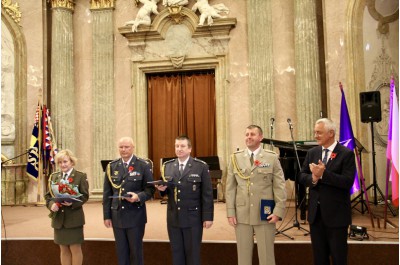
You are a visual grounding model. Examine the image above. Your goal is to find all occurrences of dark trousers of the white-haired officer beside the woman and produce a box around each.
[113,224,145,265]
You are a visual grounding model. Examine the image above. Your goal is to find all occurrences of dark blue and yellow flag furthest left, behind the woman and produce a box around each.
[26,104,42,181]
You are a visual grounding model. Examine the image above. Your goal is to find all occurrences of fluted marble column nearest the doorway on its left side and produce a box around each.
[91,0,116,199]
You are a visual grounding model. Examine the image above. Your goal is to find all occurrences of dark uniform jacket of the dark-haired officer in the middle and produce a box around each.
[162,157,214,228]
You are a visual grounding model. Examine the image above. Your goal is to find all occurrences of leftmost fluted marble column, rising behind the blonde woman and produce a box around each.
[50,0,75,152]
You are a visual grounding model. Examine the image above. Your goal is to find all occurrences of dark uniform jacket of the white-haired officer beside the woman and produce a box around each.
[103,156,155,228]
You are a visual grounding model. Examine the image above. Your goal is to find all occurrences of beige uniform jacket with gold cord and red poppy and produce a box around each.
[226,149,286,225]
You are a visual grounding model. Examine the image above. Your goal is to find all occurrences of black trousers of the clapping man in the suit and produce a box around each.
[310,206,347,265]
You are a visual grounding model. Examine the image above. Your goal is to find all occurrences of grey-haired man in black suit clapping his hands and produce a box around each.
[300,118,356,265]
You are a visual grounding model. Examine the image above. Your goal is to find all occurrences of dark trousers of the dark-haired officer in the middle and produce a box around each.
[168,225,203,265]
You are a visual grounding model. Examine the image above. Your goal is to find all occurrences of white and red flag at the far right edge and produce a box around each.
[386,77,399,207]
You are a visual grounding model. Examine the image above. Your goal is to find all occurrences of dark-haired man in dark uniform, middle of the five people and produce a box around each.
[156,136,214,265]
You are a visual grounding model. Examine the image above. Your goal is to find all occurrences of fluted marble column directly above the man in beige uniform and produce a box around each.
[247,0,275,128]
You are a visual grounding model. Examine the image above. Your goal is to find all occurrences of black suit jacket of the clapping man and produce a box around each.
[300,143,356,227]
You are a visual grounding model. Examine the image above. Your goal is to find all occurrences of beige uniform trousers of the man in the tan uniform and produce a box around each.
[235,223,275,265]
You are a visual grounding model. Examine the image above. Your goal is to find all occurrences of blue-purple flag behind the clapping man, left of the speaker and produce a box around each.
[339,83,360,194]
